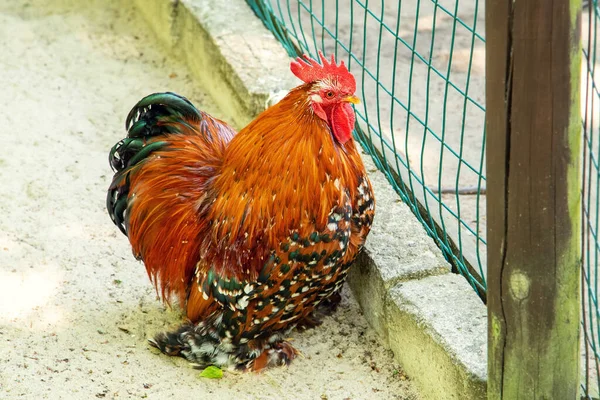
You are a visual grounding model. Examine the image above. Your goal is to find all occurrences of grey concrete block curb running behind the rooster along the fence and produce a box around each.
[135,0,487,399]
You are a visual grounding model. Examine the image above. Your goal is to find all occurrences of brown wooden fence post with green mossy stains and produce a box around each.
[486,0,581,400]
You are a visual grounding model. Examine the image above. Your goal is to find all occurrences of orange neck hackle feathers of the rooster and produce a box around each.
[206,84,363,278]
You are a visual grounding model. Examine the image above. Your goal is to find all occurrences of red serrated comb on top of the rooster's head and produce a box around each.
[290,51,356,93]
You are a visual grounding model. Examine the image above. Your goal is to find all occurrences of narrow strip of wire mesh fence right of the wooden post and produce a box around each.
[581,0,600,398]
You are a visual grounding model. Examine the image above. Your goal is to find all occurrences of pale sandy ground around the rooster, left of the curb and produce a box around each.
[0,0,417,399]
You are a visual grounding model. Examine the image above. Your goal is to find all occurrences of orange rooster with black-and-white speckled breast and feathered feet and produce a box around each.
[107,53,375,371]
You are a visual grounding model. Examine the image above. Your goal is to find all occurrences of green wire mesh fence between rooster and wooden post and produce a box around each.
[247,0,486,297]
